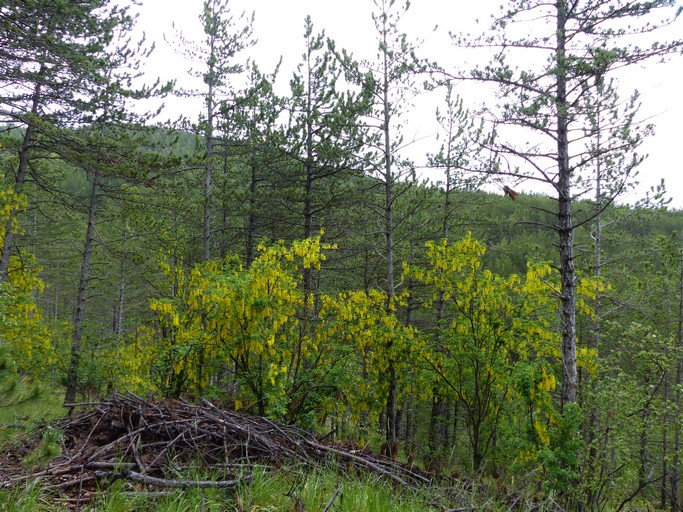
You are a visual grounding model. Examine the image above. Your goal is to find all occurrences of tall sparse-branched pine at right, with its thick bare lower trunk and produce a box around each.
[455,0,682,410]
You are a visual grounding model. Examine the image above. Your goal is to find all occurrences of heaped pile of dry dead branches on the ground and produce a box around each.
[0,393,428,495]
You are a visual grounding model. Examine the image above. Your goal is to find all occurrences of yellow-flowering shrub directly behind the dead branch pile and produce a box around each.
[143,236,352,422]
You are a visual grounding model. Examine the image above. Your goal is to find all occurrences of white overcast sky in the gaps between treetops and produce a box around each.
[138,0,683,208]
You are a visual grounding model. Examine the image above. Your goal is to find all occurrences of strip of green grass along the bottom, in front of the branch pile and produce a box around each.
[0,467,561,512]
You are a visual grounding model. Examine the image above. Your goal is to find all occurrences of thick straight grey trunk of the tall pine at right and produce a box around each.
[556,0,577,406]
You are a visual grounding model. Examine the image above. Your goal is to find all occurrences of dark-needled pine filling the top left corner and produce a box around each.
[0,0,132,280]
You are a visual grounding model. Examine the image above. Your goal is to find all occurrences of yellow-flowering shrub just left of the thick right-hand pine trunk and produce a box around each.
[404,235,560,469]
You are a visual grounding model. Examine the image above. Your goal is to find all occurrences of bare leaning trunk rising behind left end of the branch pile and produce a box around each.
[64,168,102,403]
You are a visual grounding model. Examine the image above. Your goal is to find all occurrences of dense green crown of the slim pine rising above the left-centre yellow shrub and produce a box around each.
[284,16,369,295]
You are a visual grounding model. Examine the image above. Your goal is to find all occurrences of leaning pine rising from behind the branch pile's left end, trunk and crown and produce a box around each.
[60,11,172,403]
